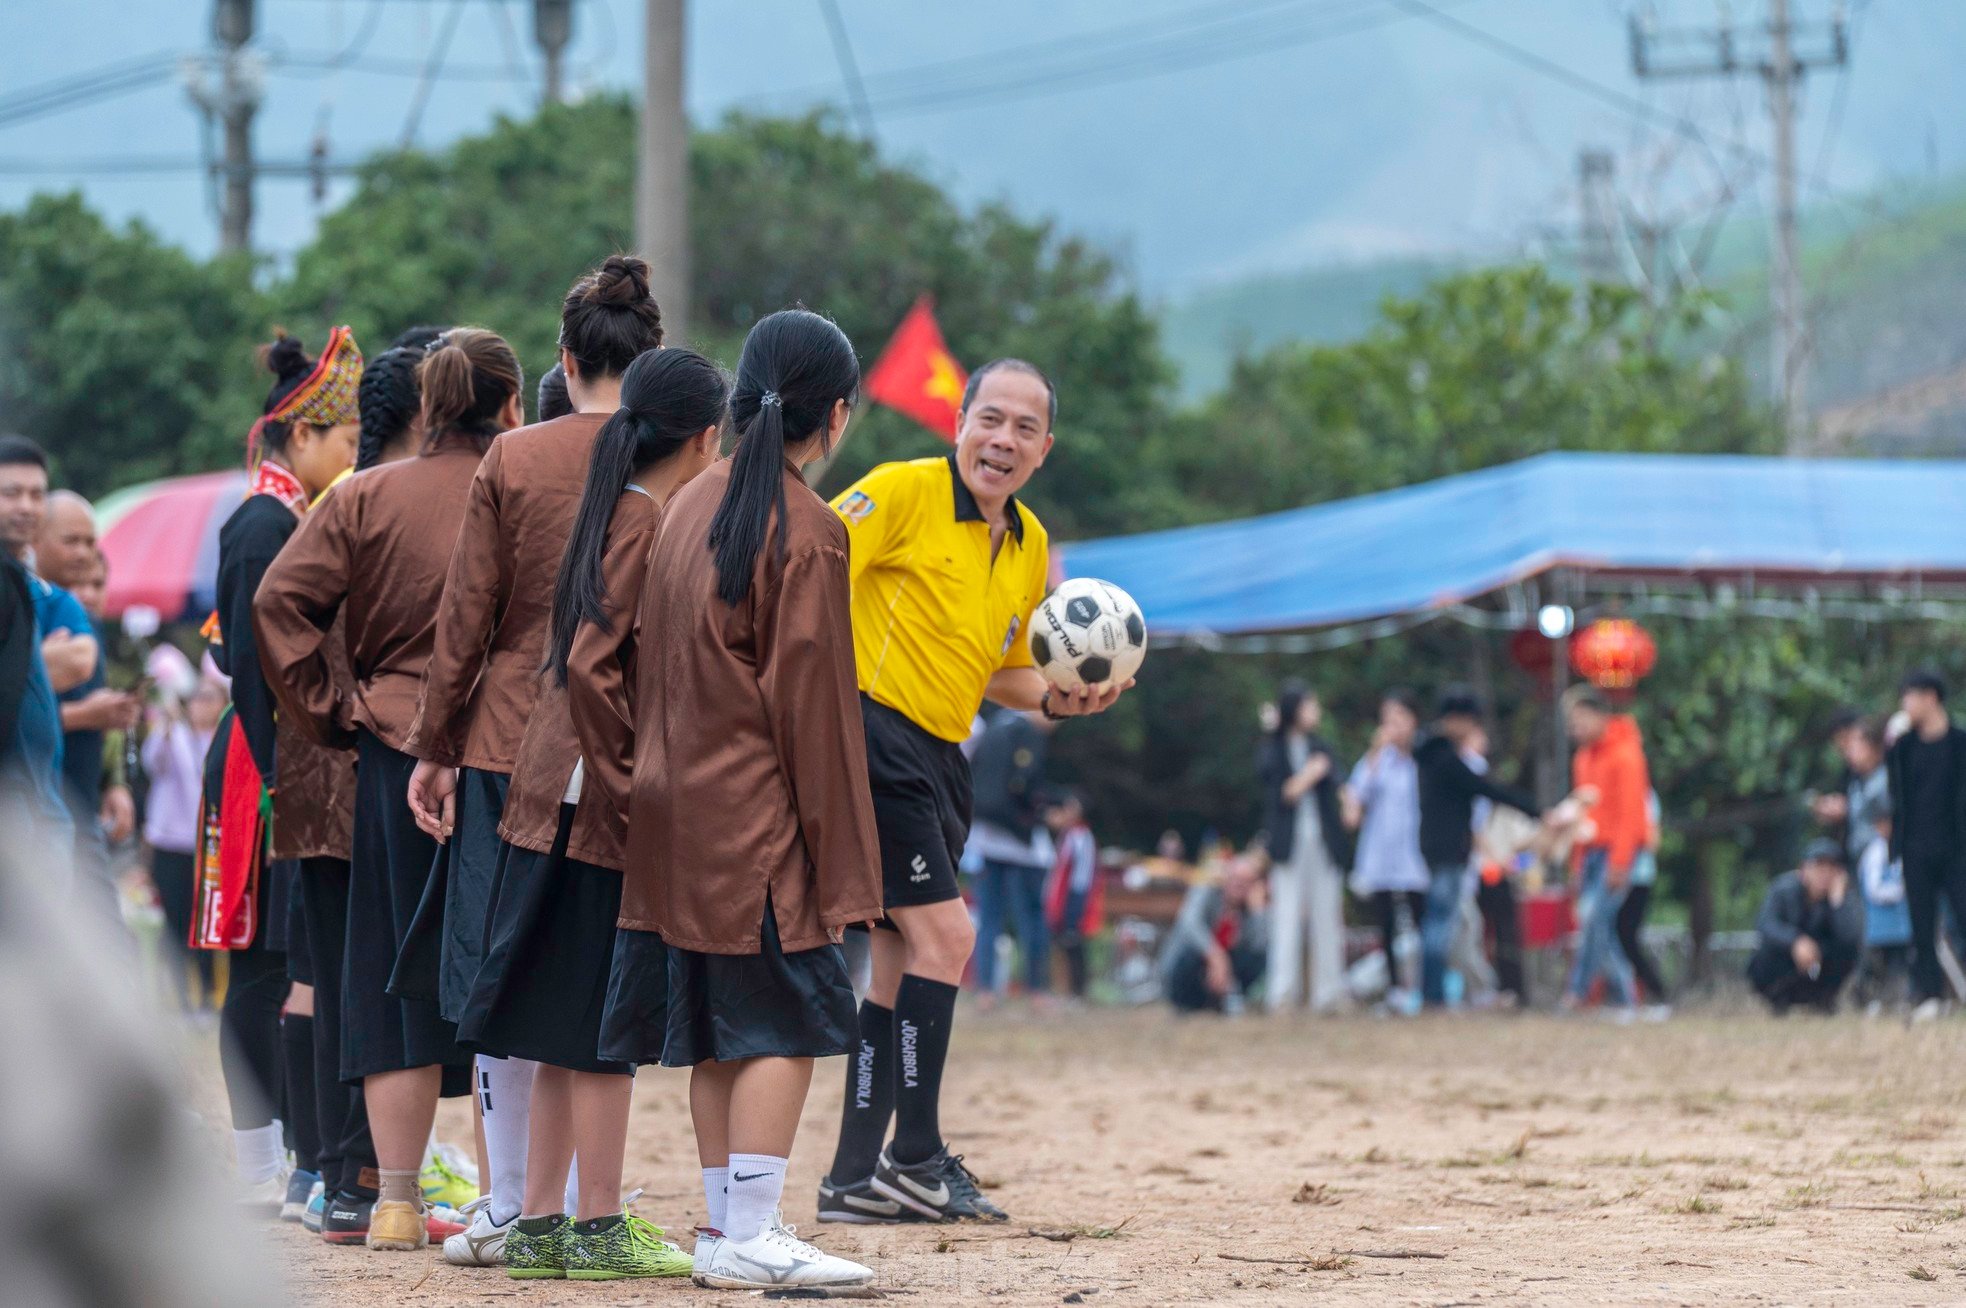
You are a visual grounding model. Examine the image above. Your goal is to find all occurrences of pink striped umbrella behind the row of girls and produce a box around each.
[96,468,248,622]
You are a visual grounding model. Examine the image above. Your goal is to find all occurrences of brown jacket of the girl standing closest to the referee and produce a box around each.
[619,462,881,954]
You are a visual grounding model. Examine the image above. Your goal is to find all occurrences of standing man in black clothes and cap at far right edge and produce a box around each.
[1885,669,1966,1021]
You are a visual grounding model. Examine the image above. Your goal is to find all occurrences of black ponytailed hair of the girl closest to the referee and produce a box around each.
[710,309,859,604]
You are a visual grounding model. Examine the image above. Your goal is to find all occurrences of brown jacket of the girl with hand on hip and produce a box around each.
[254,443,478,749]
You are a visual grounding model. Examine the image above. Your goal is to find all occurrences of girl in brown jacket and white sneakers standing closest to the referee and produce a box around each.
[602,309,881,1288]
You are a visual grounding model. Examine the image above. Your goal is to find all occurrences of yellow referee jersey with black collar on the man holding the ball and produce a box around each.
[834,454,1050,742]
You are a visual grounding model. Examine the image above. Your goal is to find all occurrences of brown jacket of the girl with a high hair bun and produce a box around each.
[403,413,607,773]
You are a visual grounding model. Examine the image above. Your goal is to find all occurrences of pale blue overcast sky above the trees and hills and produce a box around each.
[15,0,1966,293]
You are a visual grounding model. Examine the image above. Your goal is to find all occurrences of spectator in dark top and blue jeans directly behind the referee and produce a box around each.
[969,710,1056,1007]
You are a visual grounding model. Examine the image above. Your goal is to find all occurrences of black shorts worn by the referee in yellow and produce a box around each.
[861,694,969,930]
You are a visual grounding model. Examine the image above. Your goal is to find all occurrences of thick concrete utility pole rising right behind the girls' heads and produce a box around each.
[635,0,690,340]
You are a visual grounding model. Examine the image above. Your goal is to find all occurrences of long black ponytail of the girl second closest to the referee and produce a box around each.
[547,350,729,686]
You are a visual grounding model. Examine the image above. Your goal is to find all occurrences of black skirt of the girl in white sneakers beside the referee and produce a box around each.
[602,899,859,1068]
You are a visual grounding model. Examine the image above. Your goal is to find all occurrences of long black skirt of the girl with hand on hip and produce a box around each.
[342,730,472,1094]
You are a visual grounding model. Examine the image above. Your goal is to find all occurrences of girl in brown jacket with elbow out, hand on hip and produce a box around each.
[258,327,521,1249]
